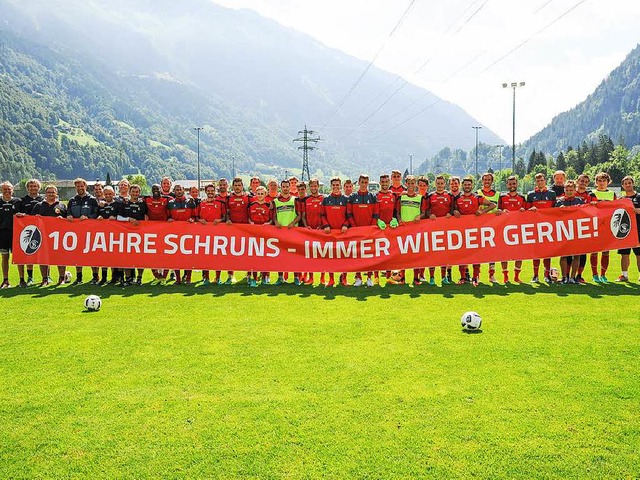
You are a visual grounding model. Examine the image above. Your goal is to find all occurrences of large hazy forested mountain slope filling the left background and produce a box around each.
[0,0,501,180]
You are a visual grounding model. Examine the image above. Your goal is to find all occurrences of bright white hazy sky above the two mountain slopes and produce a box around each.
[214,0,640,144]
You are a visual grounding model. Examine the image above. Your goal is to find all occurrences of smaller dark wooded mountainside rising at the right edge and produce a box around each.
[524,45,640,155]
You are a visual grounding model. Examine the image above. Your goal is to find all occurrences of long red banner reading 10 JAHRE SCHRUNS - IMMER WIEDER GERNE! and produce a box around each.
[13,200,639,272]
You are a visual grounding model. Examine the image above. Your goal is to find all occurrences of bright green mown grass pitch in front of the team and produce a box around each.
[0,255,640,479]
